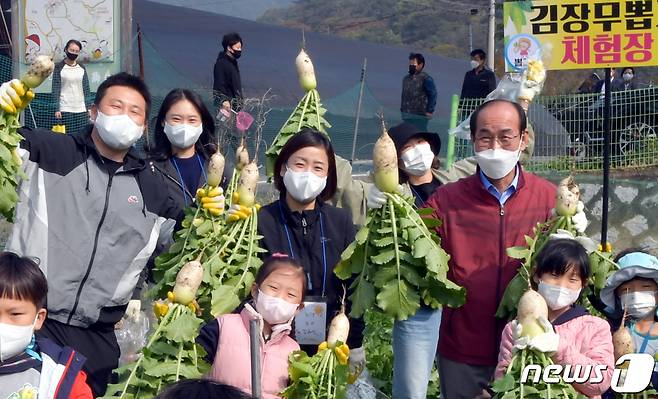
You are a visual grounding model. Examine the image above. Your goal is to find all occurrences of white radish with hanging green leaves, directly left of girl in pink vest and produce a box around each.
[105,261,210,399]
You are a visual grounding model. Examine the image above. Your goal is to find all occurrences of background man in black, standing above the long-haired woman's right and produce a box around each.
[213,33,242,110]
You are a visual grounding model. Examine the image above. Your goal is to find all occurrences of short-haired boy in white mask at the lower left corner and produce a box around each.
[0,252,93,399]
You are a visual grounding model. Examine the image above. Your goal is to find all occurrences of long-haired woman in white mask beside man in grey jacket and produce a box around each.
[149,89,216,208]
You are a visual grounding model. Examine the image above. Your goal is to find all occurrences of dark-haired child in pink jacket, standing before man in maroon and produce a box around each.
[495,239,614,398]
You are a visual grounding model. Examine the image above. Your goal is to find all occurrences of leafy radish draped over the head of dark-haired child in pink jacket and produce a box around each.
[496,176,619,319]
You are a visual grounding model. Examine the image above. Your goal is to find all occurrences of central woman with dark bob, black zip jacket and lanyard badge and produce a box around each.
[258,129,363,353]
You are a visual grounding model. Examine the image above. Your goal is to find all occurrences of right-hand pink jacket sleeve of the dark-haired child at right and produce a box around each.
[553,316,615,396]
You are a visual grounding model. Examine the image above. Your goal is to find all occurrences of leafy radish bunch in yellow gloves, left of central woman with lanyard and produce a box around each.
[152,149,265,320]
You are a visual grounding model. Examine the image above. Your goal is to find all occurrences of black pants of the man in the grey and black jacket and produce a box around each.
[37,319,121,398]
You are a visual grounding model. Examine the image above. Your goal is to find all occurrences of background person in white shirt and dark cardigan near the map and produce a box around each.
[52,39,91,133]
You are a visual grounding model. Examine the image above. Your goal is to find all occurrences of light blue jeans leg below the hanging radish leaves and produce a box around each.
[393,308,441,399]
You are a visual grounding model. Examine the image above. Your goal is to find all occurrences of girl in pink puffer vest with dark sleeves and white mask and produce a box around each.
[197,253,306,399]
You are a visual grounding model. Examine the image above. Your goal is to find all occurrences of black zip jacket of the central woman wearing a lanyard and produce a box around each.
[258,197,364,348]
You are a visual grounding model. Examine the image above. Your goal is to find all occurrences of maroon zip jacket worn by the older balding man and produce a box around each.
[427,169,556,366]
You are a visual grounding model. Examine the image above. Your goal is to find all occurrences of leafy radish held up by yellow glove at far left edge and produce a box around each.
[0,55,54,222]
